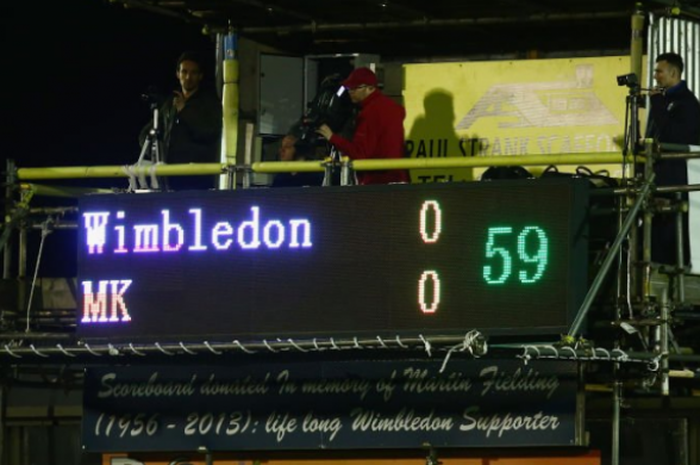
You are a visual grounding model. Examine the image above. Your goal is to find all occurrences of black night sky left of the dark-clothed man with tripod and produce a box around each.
[0,0,215,170]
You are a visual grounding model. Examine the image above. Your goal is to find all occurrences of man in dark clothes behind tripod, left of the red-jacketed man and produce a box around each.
[139,52,222,190]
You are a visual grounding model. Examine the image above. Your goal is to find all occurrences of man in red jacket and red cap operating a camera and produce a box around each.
[317,68,409,184]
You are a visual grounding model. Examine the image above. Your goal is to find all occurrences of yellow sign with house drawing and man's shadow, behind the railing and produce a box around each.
[403,57,630,182]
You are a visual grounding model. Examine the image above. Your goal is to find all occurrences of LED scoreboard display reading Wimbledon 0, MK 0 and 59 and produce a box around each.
[77,179,588,340]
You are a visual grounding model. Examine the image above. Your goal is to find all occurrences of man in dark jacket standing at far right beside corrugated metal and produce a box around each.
[647,53,700,264]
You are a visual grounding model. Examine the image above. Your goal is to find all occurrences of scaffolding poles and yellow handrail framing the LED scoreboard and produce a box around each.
[0,140,700,463]
